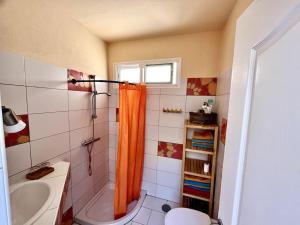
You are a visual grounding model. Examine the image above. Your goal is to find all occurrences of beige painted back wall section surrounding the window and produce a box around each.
[108,31,221,78]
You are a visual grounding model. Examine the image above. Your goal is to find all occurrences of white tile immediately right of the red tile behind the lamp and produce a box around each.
[29,112,69,141]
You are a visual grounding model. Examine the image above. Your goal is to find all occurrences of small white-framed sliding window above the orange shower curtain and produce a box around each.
[115,59,181,87]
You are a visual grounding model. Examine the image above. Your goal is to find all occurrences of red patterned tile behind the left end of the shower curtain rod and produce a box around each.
[68,69,92,92]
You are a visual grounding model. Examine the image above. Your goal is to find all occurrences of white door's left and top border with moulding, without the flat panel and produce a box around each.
[219,0,300,225]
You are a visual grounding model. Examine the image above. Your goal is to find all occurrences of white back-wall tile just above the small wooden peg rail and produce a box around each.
[160,95,186,111]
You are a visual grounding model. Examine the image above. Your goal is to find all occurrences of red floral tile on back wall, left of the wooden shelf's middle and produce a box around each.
[157,141,183,160]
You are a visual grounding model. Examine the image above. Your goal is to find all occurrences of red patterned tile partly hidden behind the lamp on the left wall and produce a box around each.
[5,115,30,147]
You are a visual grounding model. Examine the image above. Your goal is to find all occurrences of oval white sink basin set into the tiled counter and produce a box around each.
[10,181,55,225]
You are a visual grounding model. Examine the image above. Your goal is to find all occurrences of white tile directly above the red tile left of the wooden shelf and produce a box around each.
[159,127,183,144]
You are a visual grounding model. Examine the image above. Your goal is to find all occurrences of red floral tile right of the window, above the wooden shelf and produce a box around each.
[186,78,218,96]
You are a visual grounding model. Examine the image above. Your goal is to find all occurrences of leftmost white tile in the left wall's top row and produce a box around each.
[0,52,25,85]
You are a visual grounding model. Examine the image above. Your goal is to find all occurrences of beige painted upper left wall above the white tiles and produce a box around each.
[0,0,107,77]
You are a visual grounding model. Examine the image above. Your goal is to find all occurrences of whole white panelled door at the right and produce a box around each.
[219,0,300,225]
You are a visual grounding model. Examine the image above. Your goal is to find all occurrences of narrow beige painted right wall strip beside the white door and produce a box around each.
[218,0,253,74]
